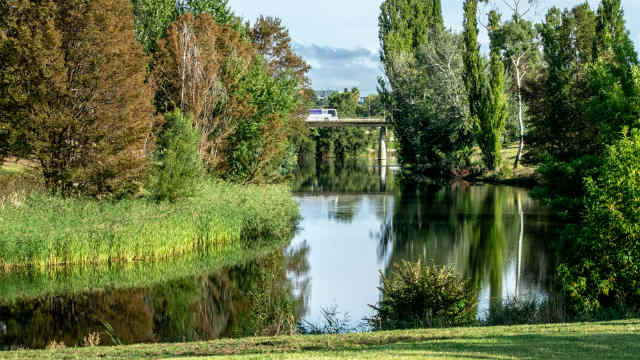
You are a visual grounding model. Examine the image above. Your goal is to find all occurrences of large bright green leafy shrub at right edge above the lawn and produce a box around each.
[559,131,640,314]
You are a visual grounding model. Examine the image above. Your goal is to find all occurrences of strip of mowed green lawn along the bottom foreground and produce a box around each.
[0,320,640,360]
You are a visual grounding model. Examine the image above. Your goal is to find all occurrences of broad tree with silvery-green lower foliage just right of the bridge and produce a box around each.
[379,1,473,175]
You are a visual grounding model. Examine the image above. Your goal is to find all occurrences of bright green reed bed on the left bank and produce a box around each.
[0,183,298,270]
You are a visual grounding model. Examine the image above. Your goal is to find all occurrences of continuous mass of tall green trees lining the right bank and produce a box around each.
[379,0,640,315]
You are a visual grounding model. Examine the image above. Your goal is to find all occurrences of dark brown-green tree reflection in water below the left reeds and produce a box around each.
[0,246,308,349]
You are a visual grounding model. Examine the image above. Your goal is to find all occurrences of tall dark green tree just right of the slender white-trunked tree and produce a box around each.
[523,4,597,161]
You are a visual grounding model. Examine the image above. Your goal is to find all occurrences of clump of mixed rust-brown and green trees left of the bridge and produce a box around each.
[154,13,308,182]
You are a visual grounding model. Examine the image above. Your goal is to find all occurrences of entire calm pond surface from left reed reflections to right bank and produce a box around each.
[0,163,554,349]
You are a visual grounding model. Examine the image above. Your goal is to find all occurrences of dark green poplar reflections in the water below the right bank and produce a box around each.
[374,183,552,311]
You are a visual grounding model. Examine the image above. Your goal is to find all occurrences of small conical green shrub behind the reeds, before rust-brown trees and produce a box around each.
[151,110,202,201]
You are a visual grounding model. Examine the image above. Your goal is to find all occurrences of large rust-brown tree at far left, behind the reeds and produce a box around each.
[0,0,153,196]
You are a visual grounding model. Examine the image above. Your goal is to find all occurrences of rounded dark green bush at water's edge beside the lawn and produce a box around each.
[369,261,476,330]
